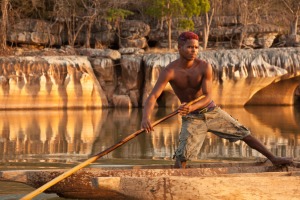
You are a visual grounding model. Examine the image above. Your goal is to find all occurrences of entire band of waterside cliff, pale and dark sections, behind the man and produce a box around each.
[0,48,300,109]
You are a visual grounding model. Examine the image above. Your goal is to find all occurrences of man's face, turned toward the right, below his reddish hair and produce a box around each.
[179,39,199,60]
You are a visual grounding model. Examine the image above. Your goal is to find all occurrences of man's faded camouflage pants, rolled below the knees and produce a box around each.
[174,107,250,161]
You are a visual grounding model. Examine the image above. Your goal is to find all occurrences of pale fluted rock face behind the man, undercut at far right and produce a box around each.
[143,48,300,106]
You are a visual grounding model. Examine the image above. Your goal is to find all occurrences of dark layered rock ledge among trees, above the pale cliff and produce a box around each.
[7,16,300,49]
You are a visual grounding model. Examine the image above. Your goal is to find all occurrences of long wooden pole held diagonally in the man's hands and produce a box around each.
[20,96,204,200]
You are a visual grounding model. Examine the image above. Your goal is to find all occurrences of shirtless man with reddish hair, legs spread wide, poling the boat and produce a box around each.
[141,32,293,168]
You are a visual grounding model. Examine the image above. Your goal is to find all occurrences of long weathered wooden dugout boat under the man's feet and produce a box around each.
[0,162,300,200]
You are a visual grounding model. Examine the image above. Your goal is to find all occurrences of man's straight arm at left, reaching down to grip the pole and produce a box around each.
[141,69,171,132]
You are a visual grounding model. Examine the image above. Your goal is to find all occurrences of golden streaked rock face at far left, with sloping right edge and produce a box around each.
[0,56,107,109]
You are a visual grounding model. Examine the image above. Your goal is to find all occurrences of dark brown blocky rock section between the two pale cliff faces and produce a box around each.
[90,55,144,107]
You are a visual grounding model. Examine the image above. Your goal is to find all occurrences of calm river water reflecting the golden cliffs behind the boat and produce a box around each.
[0,106,300,200]
